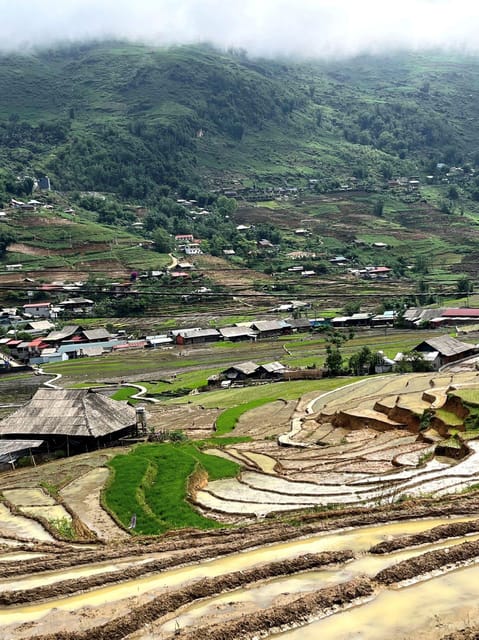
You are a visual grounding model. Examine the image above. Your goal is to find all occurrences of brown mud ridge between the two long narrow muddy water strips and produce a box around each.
[28,551,357,640]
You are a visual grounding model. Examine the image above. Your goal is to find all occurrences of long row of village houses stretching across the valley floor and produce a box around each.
[0,298,479,371]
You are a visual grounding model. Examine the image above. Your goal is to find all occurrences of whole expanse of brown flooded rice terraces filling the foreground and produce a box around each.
[0,372,479,640]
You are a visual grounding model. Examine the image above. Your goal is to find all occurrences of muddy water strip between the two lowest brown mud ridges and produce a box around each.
[147,534,479,640]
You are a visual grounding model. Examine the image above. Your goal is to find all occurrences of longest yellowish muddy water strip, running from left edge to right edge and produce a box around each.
[0,516,474,625]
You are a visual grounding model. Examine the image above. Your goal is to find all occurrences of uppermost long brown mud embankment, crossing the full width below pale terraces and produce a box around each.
[2,492,479,589]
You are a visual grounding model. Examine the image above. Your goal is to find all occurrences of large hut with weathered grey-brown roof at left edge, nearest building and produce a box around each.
[0,388,135,448]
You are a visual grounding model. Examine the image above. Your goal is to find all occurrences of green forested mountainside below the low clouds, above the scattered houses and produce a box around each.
[0,43,479,202]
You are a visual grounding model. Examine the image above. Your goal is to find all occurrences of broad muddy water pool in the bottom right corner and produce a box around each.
[273,565,479,640]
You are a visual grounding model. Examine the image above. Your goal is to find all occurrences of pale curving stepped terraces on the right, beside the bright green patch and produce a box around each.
[195,372,479,517]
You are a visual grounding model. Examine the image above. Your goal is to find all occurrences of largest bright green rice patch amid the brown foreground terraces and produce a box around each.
[104,443,239,535]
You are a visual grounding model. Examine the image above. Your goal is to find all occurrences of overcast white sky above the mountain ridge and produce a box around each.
[0,0,479,57]
